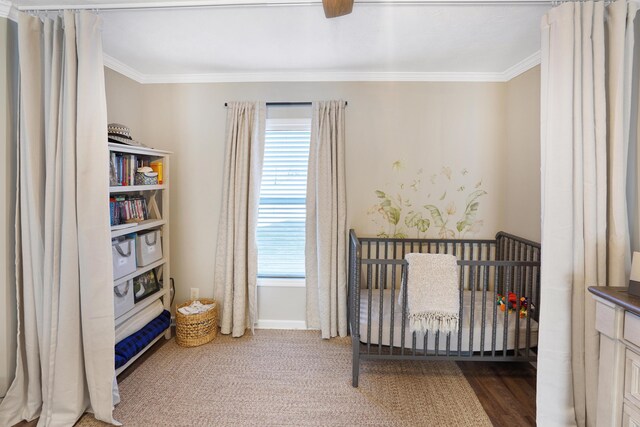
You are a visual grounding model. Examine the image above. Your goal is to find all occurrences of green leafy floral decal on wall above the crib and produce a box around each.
[368,160,487,238]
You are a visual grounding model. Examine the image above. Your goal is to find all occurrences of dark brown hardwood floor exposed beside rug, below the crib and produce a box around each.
[458,362,536,427]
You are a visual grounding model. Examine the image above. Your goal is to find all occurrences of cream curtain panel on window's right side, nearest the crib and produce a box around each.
[305,101,347,338]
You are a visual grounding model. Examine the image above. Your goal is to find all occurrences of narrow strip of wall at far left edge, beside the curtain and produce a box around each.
[0,18,18,398]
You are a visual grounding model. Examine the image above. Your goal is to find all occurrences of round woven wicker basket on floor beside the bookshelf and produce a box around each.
[176,298,218,347]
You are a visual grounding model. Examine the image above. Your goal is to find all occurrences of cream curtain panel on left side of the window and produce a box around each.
[214,102,266,337]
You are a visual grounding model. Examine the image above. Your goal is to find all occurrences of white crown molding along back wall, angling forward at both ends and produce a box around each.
[104,51,540,84]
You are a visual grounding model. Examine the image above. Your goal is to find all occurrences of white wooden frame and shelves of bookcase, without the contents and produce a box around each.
[109,143,172,375]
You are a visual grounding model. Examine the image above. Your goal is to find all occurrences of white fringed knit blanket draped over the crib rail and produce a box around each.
[399,253,460,334]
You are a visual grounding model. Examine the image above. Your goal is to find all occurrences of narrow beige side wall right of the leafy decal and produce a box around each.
[505,66,541,242]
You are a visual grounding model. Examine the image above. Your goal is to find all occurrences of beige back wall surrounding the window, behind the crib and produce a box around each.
[106,70,539,326]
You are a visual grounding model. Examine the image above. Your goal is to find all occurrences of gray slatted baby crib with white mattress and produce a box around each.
[348,230,540,387]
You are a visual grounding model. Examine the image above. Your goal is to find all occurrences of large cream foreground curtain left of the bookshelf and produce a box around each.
[0,12,114,426]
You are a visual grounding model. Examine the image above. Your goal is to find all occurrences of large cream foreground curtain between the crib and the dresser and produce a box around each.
[537,0,636,426]
